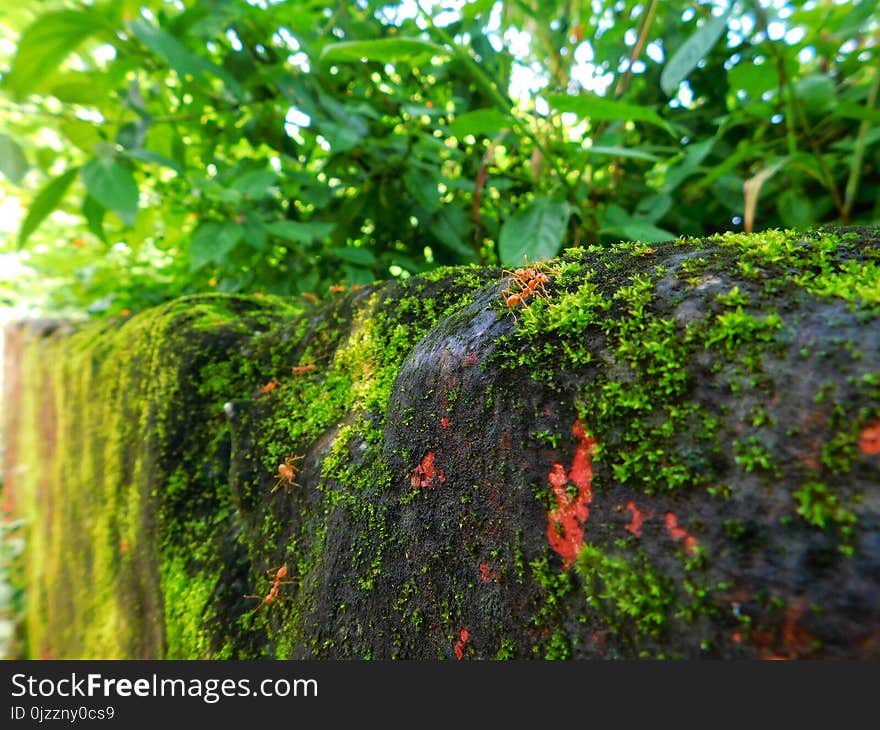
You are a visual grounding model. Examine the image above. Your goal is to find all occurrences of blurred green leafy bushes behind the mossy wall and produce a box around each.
[0,0,880,316]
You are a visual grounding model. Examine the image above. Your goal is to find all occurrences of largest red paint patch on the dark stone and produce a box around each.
[547,419,596,570]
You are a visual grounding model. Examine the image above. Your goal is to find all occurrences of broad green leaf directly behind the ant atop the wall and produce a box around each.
[498,197,571,266]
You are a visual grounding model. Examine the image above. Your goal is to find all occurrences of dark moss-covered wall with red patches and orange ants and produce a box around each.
[6,229,880,659]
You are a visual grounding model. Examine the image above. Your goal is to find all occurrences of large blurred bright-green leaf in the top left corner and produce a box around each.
[3,8,104,99]
